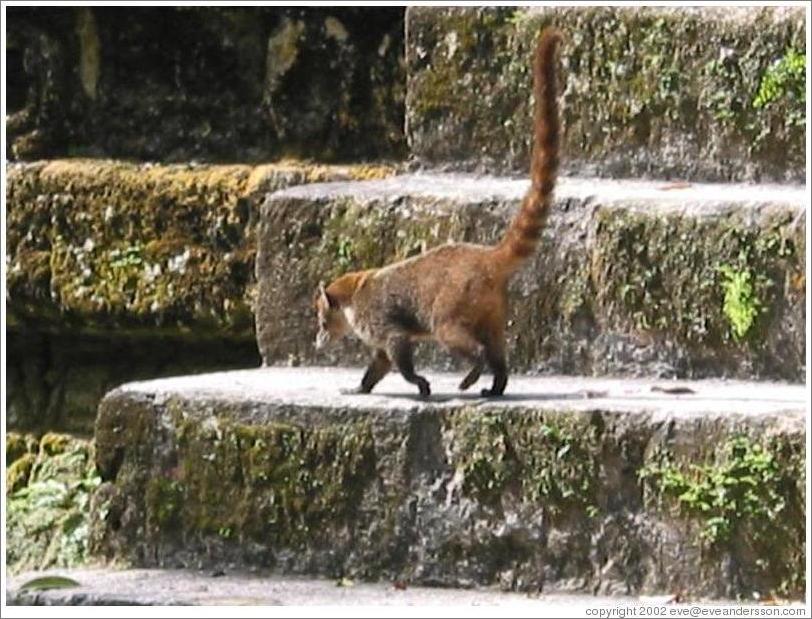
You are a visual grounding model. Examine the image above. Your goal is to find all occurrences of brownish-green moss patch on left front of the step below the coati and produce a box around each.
[146,413,374,545]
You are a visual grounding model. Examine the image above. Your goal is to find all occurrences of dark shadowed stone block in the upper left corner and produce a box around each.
[6,6,405,162]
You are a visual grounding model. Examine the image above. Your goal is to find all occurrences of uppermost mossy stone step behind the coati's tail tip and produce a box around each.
[406,6,806,182]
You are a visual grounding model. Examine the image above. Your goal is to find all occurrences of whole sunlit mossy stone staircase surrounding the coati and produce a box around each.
[8,8,809,602]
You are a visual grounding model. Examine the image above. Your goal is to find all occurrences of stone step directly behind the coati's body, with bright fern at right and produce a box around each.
[256,173,807,381]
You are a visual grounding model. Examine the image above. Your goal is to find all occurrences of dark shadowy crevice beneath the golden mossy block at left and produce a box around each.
[5,327,260,436]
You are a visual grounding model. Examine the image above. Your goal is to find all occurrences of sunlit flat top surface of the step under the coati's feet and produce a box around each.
[119,367,806,422]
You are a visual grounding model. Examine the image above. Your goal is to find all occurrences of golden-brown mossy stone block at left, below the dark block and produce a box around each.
[6,159,390,336]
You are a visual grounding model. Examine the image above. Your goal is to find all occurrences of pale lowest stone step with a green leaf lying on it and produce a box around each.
[6,568,640,616]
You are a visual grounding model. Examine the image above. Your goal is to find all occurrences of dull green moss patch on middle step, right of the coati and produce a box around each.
[592,209,799,346]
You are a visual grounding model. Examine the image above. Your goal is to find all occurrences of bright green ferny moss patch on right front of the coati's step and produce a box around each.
[638,435,805,596]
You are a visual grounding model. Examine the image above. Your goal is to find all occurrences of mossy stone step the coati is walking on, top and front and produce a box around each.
[90,368,807,599]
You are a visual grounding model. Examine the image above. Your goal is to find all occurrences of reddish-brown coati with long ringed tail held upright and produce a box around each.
[314,28,561,397]
